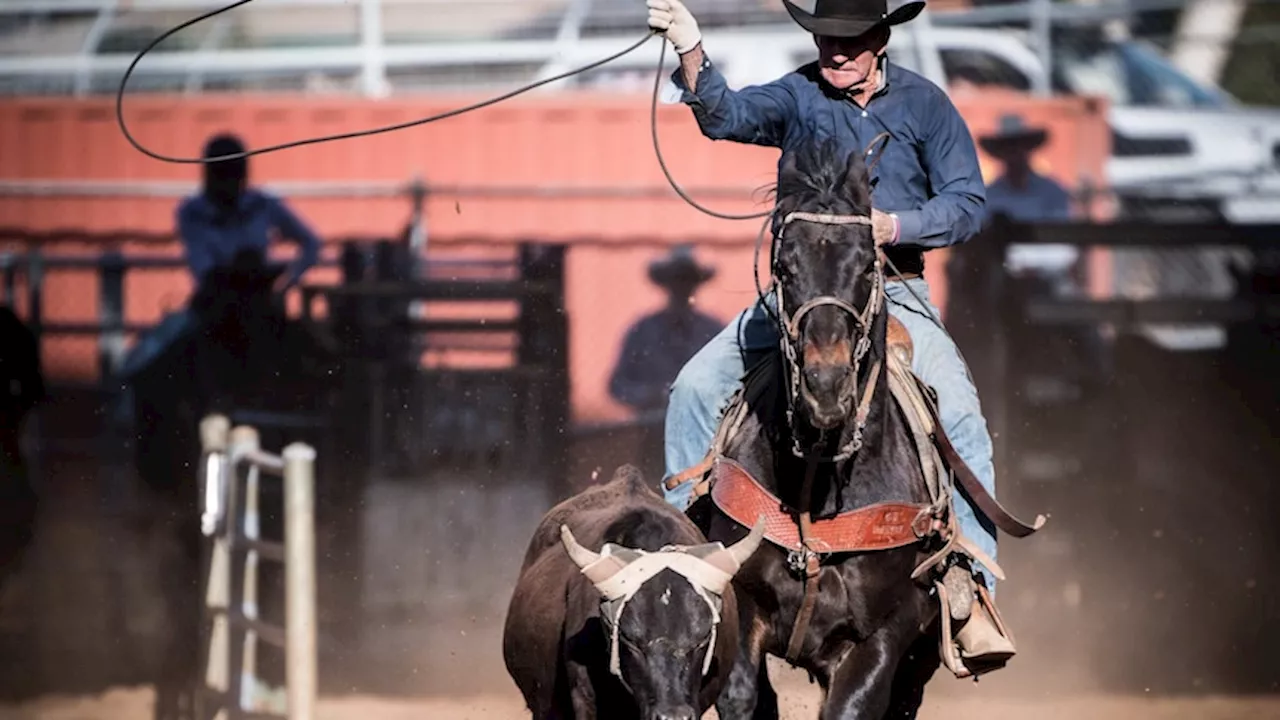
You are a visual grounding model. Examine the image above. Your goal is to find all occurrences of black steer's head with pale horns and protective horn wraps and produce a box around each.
[561,520,764,720]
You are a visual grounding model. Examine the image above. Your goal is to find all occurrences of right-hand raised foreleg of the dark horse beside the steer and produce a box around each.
[819,611,920,720]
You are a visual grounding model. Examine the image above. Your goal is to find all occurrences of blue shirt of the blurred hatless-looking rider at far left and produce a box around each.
[177,190,320,284]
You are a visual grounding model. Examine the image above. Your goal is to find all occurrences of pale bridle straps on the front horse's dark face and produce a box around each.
[762,211,884,462]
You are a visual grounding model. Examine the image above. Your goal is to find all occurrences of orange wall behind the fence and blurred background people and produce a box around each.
[0,95,1110,420]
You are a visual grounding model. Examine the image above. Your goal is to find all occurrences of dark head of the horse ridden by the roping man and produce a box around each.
[773,142,883,429]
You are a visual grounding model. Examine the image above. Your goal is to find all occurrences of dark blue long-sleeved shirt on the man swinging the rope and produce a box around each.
[672,53,986,249]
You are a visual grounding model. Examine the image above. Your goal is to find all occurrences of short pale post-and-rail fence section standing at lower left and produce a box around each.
[197,415,317,720]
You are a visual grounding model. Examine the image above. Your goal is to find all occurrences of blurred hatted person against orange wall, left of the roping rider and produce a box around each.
[609,245,724,418]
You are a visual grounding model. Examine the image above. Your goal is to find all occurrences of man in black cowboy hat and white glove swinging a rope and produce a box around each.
[648,0,1015,667]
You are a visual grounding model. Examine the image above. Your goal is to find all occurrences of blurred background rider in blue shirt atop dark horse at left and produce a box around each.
[178,133,320,291]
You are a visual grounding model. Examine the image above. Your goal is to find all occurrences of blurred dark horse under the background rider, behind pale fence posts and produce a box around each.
[128,252,340,720]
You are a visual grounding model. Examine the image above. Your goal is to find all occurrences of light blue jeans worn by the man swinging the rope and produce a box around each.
[663,278,997,589]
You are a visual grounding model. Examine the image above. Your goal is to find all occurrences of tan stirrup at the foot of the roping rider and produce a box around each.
[934,573,1018,679]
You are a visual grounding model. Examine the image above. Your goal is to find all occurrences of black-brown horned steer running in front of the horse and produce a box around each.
[503,465,764,720]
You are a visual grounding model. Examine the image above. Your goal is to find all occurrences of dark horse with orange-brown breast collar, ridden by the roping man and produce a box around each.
[690,145,950,720]
